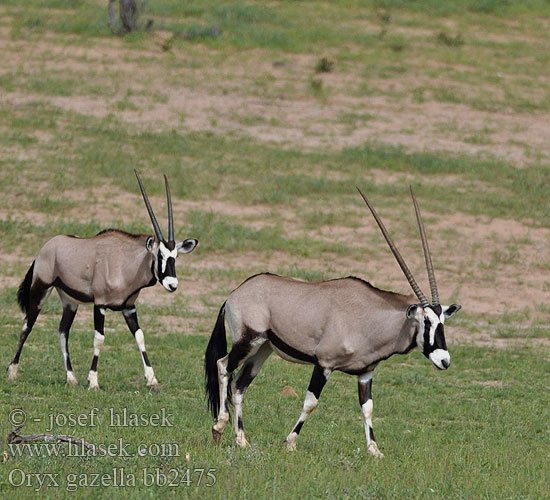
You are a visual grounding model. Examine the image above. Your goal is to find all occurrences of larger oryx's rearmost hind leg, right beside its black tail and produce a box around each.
[212,334,267,443]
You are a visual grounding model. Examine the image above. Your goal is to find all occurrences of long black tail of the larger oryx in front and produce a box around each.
[204,302,227,419]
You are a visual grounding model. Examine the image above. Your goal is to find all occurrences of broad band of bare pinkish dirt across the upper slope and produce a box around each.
[0,29,550,164]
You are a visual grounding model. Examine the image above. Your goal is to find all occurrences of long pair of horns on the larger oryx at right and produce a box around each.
[357,186,439,307]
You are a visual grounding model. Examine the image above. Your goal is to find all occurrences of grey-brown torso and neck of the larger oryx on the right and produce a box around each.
[226,274,417,373]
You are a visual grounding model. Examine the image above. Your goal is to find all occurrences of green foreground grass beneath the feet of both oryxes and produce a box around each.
[0,326,550,499]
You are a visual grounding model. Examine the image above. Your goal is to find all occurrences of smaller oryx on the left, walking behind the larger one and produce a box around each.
[8,170,198,391]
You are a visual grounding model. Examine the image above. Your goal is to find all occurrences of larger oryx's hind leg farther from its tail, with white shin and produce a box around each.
[231,342,273,448]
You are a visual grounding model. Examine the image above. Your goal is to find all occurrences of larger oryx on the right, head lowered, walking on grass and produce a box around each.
[204,187,461,457]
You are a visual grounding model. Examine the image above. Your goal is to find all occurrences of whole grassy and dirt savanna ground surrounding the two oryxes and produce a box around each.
[0,0,550,499]
